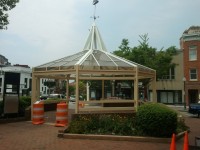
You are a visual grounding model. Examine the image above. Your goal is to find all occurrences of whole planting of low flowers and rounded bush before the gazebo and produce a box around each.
[65,103,189,137]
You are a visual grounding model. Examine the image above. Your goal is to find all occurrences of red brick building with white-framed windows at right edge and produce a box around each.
[180,26,200,105]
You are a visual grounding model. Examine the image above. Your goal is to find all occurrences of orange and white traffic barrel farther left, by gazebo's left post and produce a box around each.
[32,103,44,125]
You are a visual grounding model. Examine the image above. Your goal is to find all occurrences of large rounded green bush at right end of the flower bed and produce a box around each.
[135,103,177,137]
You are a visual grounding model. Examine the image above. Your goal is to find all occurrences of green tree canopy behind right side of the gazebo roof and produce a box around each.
[113,34,177,79]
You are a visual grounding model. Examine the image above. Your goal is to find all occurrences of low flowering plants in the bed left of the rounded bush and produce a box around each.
[65,113,135,135]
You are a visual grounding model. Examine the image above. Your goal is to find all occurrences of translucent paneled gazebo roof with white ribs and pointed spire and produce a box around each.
[33,23,155,77]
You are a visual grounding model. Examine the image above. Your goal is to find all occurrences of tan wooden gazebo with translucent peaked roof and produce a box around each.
[32,21,157,113]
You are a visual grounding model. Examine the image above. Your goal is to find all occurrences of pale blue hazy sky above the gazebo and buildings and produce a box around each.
[0,0,200,67]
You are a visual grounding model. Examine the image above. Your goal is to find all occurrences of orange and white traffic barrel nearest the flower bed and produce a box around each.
[55,103,68,127]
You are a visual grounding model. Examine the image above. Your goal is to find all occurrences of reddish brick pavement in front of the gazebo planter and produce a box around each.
[0,107,200,150]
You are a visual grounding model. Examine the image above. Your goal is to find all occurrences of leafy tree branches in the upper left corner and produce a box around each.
[0,0,19,29]
